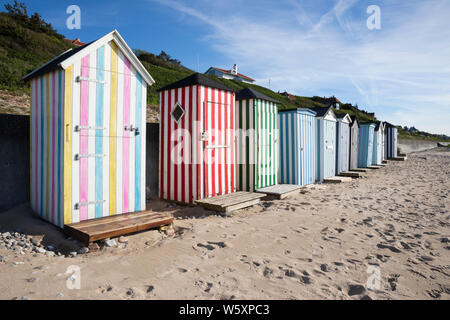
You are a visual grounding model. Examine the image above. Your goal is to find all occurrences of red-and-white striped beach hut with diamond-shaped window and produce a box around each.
[158,73,236,203]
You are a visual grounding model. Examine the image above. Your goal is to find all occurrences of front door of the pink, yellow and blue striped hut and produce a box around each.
[72,64,141,222]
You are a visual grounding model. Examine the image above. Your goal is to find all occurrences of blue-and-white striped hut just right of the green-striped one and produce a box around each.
[279,108,317,186]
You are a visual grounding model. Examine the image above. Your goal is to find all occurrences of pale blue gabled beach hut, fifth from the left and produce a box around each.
[314,107,337,181]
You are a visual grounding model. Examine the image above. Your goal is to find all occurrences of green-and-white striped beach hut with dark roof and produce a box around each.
[236,88,279,192]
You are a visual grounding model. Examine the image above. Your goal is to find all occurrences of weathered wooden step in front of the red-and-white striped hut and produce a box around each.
[195,191,267,215]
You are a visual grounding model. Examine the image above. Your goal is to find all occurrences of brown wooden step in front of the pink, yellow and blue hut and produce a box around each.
[64,211,173,245]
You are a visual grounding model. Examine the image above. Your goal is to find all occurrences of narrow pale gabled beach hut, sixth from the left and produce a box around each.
[336,113,352,174]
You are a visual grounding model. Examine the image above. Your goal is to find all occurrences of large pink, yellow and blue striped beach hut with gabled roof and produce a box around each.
[24,30,154,227]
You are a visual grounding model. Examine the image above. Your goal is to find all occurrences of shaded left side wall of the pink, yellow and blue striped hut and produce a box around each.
[30,70,65,227]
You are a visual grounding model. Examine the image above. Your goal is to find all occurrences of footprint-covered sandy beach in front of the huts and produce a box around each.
[0,150,450,300]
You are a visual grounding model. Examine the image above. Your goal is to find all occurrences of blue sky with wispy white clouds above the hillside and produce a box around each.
[4,0,450,135]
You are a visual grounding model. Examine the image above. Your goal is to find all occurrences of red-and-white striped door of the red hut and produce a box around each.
[202,101,234,198]
